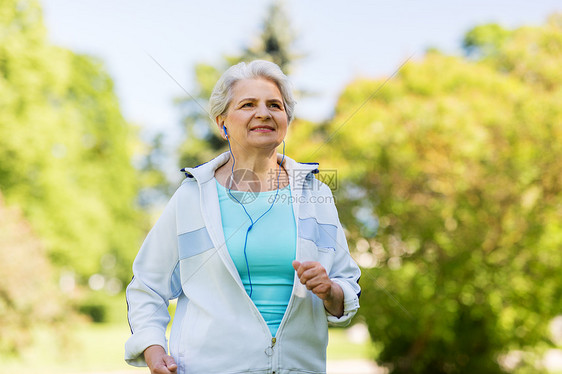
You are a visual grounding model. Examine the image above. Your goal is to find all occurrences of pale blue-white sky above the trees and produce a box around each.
[41,0,562,146]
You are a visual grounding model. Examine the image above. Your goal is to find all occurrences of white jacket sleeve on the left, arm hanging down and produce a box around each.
[125,195,181,366]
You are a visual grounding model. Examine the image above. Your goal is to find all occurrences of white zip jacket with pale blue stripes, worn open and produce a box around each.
[125,153,360,374]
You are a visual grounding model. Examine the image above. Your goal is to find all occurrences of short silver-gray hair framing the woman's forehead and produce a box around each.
[209,60,296,123]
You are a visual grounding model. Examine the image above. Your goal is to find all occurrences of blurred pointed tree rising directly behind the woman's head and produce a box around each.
[179,2,299,166]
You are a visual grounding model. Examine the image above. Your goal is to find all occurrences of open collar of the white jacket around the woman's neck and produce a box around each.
[181,151,318,188]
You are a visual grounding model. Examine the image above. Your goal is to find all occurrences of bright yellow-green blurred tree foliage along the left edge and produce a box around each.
[0,1,144,282]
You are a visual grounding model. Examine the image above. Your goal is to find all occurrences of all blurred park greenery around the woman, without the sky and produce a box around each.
[0,0,562,373]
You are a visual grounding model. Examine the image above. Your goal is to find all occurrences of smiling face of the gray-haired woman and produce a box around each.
[217,78,288,152]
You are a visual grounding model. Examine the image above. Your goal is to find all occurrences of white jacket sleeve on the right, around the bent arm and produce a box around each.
[326,188,361,326]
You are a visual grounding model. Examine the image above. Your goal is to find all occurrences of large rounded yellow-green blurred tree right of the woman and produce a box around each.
[289,16,562,373]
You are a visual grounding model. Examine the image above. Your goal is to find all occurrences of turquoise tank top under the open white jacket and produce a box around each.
[216,181,297,336]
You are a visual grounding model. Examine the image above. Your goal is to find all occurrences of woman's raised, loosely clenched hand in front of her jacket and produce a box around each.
[293,261,343,317]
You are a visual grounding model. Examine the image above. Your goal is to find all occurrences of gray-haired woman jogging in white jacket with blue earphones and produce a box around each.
[125,60,360,374]
